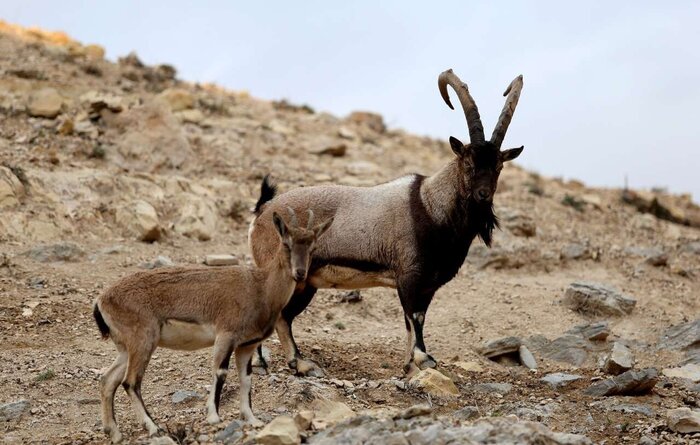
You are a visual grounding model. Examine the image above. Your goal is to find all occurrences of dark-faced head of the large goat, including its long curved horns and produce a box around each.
[438,70,524,202]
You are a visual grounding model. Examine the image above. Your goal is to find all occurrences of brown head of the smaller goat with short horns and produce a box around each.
[272,207,333,282]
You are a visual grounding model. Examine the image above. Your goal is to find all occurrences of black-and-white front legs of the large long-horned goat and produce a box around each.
[398,279,437,377]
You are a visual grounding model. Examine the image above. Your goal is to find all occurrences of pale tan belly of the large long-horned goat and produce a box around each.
[308,266,396,289]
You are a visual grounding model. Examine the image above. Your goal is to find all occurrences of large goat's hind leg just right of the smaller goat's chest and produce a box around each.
[275,286,324,377]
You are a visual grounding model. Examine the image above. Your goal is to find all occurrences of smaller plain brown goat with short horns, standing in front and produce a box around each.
[94,209,332,442]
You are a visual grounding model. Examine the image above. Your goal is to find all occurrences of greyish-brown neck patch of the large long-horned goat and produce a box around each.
[421,159,467,224]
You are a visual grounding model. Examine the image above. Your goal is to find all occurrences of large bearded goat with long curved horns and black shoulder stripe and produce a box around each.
[249,70,523,375]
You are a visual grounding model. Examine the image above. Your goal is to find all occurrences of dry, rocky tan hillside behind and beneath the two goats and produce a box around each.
[0,22,700,444]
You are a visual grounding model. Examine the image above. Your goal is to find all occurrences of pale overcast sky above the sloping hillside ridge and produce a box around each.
[0,0,700,201]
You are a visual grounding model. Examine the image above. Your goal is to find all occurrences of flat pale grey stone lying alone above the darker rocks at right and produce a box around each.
[564,282,637,316]
